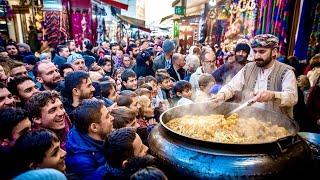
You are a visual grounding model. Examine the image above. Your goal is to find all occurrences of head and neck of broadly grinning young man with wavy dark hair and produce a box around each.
[25,91,71,149]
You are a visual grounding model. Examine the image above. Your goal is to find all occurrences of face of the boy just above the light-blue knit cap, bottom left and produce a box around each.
[38,141,67,172]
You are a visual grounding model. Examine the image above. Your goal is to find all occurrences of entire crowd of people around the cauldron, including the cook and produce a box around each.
[0,34,320,179]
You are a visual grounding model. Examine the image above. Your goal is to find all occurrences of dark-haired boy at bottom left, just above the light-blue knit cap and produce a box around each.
[12,129,66,179]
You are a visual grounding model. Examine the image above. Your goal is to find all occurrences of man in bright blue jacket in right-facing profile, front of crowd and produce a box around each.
[66,99,114,179]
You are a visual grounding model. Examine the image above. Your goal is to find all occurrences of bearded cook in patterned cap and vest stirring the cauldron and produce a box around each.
[214,34,298,118]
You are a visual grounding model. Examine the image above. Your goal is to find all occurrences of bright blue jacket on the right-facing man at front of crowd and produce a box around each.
[66,127,106,179]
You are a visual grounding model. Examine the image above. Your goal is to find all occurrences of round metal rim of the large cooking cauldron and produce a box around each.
[160,102,299,146]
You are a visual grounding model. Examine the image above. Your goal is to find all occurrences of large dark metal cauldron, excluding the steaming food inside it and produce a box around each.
[149,103,312,179]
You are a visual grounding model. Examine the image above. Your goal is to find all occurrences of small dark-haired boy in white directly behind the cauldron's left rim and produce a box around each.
[173,80,193,106]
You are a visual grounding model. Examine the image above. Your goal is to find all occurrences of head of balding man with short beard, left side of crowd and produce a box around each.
[33,60,61,91]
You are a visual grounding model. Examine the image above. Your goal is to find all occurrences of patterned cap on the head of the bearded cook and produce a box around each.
[251,34,279,49]
